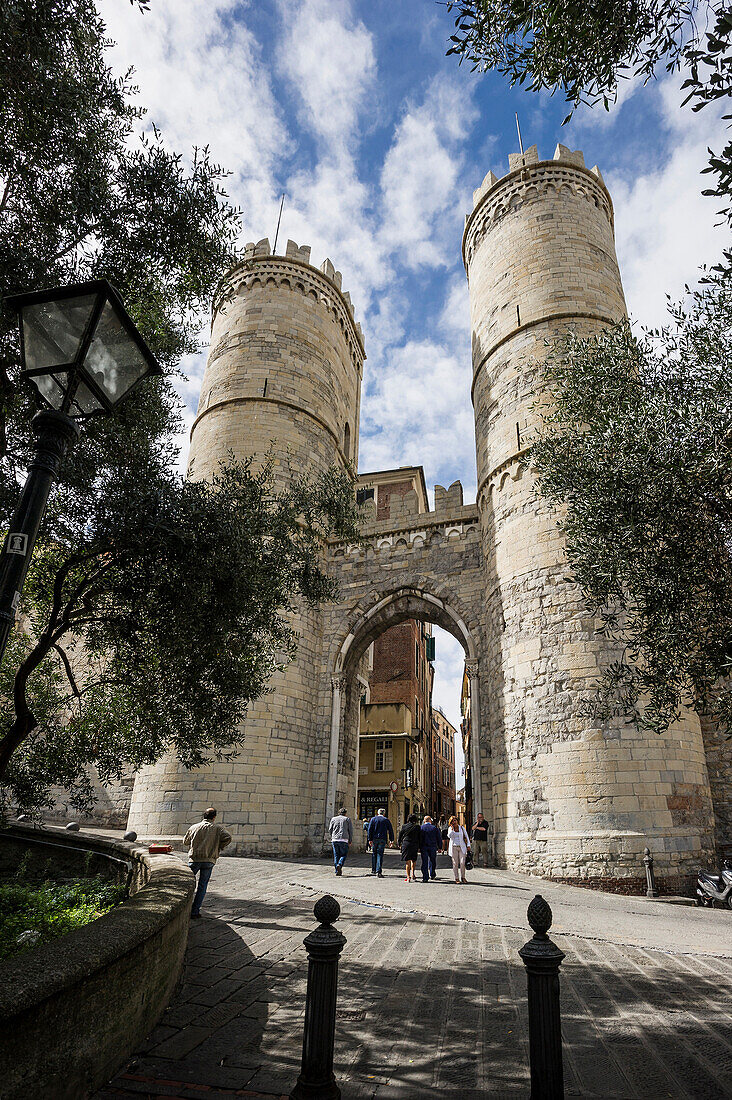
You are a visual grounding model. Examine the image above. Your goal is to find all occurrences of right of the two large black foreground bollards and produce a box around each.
[518,894,565,1100]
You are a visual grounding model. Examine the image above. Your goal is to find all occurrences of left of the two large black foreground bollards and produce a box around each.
[289,894,346,1100]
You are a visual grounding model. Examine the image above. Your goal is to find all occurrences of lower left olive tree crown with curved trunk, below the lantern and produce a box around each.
[0,462,357,811]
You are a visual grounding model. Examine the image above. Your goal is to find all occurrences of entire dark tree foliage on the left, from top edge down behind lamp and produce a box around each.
[0,0,356,809]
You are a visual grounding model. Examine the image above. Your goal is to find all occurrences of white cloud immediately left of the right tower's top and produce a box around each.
[381,76,477,267]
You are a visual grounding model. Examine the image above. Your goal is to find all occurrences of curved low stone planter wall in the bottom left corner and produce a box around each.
[0,826,194,1100]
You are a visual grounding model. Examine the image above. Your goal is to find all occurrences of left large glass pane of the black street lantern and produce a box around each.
[22,294,97,374]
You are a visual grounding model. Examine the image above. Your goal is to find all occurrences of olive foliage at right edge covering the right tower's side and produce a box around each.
[531,282,732,730]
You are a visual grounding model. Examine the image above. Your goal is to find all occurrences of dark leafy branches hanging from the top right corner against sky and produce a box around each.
[447,0,732,267]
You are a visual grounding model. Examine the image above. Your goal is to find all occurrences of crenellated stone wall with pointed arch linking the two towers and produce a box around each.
[326,482,491,820]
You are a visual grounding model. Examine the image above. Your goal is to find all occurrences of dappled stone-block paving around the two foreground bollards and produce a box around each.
[98,883,732,1100]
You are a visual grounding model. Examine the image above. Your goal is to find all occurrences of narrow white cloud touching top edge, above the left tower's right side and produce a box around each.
[280,0,376,149]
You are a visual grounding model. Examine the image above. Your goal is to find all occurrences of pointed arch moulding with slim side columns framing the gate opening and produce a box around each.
[325,582,484,824]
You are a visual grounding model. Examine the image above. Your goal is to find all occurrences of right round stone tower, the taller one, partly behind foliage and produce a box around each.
[463,145,713,880]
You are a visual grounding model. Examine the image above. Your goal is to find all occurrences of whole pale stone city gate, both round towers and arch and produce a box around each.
[130,145,714,882]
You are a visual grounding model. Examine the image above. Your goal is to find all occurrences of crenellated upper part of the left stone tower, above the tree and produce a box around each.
[188,242,364,485]
